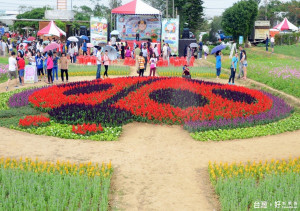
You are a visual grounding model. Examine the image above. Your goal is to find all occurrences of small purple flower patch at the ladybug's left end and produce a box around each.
[8,87,45,108]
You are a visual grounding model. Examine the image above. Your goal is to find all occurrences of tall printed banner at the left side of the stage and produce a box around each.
[90,17,107,46]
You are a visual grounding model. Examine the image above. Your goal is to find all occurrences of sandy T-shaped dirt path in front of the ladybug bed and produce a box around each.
[0,69,300,211]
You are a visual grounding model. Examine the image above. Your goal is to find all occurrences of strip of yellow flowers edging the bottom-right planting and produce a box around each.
[208,157,300,183]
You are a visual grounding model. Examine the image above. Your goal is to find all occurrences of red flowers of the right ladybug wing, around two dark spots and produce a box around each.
[112,78,272,123]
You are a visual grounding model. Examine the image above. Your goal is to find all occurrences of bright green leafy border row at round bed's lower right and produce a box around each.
[191,112,300,141]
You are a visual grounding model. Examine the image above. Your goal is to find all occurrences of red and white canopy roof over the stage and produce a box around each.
[111,0,161,15]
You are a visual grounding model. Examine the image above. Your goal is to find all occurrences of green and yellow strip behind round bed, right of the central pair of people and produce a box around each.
[157,67,229,79]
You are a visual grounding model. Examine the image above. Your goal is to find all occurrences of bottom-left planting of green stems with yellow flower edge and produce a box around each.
[0,158,113,210]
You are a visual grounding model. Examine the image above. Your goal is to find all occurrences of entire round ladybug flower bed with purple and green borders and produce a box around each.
[0,77,299,141]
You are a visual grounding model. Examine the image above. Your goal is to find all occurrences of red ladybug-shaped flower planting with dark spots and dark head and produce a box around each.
[29,77,273,126]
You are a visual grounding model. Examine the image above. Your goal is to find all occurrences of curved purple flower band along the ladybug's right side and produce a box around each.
[184,92,293,132]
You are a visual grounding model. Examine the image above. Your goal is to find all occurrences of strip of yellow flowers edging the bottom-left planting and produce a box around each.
[0,158,112,178]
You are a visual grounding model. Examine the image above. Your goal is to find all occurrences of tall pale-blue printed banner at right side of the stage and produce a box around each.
[161,18,179,55]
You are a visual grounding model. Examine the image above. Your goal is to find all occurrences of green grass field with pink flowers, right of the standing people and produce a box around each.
[208,48,300,97]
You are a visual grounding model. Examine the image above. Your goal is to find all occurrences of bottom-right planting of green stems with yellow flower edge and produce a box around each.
[208,157,300,211]
